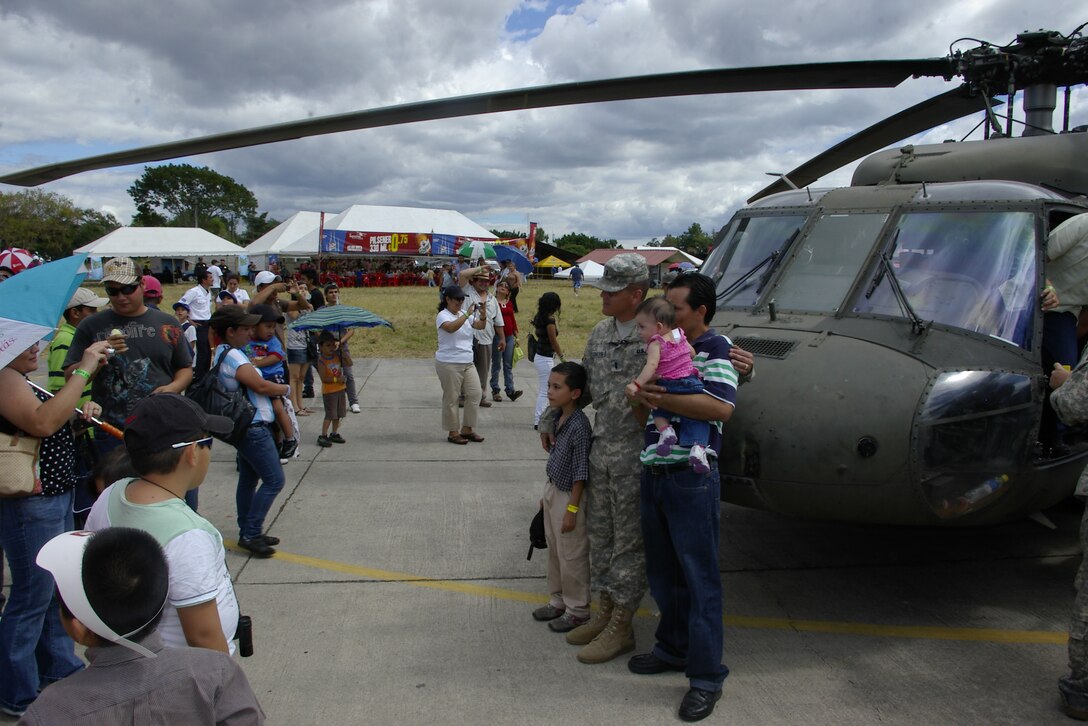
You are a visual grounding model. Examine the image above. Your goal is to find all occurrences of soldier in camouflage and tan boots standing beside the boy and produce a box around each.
[541,253,650,663]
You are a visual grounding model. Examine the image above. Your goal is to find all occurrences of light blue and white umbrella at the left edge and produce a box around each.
[0,254,87,368]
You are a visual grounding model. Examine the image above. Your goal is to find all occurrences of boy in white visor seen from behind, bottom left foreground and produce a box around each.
[29,527,264,726]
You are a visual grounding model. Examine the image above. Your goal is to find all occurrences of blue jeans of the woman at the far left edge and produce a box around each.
[0,492,83,711]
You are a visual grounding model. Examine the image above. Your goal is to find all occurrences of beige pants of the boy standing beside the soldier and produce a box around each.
[543,481,590,617]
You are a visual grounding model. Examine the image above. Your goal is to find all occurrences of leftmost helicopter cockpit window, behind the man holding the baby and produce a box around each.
[702,216,805,307]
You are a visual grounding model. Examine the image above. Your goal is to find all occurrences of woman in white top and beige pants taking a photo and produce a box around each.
[434,285,487,445]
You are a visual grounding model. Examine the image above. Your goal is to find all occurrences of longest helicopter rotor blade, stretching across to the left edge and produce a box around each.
[0,58,953,186]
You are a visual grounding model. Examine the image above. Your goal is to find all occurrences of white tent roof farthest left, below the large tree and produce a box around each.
[75,226,246,258]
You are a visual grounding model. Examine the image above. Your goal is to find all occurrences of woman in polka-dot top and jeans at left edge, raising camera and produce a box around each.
[0,341,110,716]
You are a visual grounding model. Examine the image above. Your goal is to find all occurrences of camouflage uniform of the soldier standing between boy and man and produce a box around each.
[541,255,647,610]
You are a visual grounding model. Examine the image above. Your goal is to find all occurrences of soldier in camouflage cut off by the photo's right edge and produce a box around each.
[1050,357,1088,721]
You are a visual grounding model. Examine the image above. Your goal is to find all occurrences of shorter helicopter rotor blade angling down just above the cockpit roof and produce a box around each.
[749,85,1002,204]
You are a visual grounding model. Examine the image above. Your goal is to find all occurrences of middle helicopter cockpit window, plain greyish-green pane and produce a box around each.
[774,213,888,312]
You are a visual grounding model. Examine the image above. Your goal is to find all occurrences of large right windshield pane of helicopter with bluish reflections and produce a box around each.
[853,211,1037,349]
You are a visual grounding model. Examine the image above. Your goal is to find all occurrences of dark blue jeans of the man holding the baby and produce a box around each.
[640,463,729,691]
